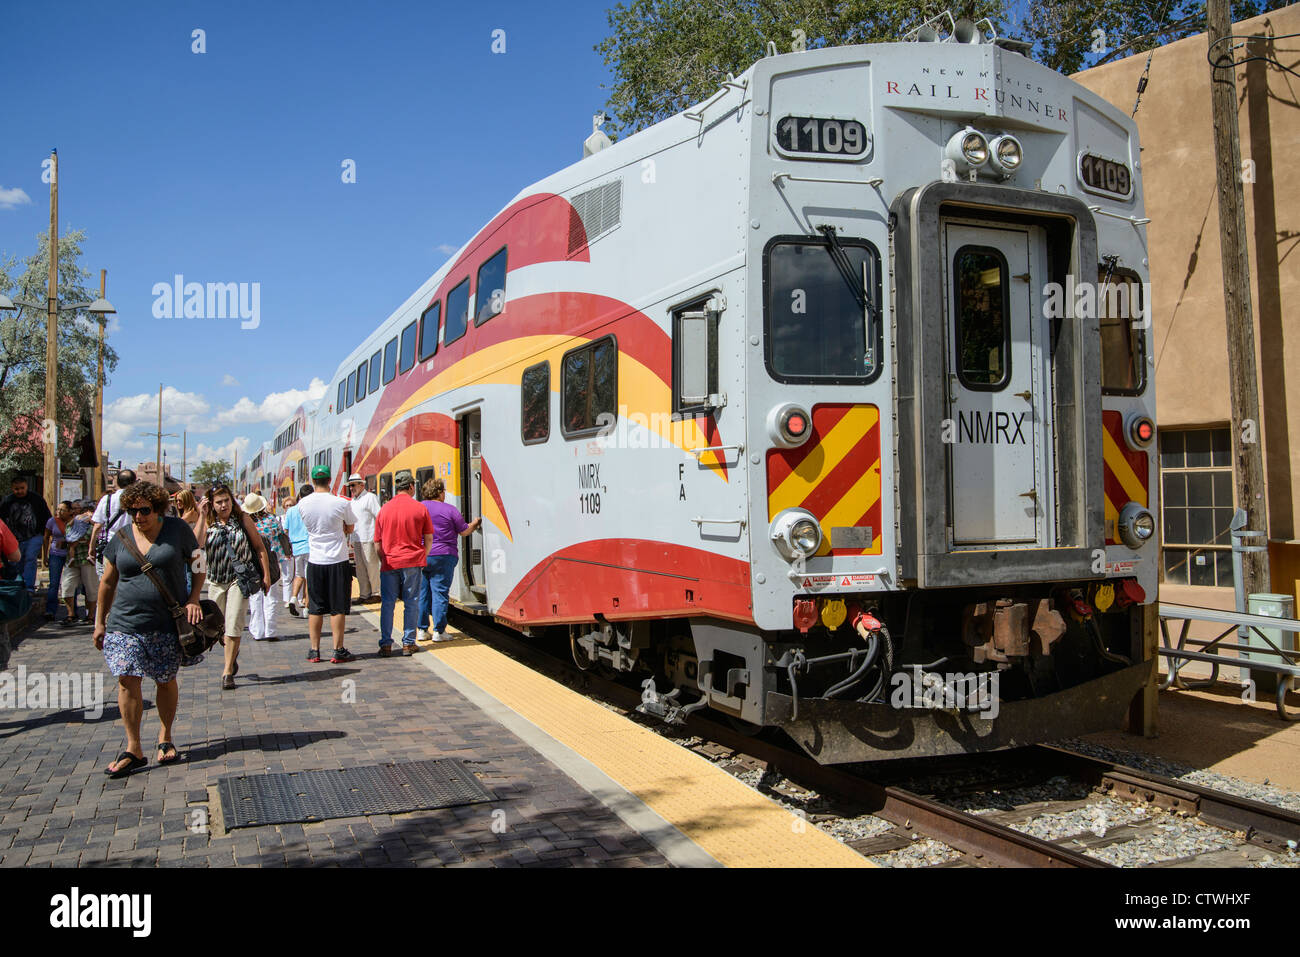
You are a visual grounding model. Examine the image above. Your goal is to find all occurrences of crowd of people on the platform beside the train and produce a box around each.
[0,465,482,778]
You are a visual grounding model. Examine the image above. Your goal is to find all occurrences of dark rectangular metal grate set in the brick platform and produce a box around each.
[217,758,493,830]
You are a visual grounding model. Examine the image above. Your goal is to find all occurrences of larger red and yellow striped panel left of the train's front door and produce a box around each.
[767,403,880,555]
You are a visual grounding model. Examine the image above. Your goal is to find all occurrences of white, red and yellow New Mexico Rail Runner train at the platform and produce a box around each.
[241,23,1158,763]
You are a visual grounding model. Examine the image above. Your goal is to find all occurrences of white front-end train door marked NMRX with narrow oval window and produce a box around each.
[943,221,1054,549]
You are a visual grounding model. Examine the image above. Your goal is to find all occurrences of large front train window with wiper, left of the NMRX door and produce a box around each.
[763,237,881,384]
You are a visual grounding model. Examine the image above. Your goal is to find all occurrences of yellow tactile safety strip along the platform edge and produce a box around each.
[351,608,874,867]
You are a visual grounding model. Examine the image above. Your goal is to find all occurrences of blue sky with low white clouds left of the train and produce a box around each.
[0,0,624,472]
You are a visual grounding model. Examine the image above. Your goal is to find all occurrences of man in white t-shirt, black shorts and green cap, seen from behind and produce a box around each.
[298,465,356,664]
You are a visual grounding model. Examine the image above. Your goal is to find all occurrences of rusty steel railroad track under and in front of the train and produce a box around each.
[454,611,1300,869]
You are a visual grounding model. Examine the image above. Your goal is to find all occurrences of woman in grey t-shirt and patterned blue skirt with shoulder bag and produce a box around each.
[94,482,203,778]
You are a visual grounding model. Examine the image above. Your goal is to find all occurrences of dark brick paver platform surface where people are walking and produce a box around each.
[0,606,666,867]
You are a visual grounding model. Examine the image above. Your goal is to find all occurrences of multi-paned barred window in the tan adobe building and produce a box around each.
[1160,428,1236,588]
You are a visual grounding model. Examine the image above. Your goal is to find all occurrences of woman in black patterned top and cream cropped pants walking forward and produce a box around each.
[203,485,270,690]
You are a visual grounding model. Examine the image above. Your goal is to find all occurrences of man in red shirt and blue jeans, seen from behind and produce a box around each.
[374,469,433,658]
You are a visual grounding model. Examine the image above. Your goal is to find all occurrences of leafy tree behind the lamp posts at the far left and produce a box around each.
[0,230,117,486]
